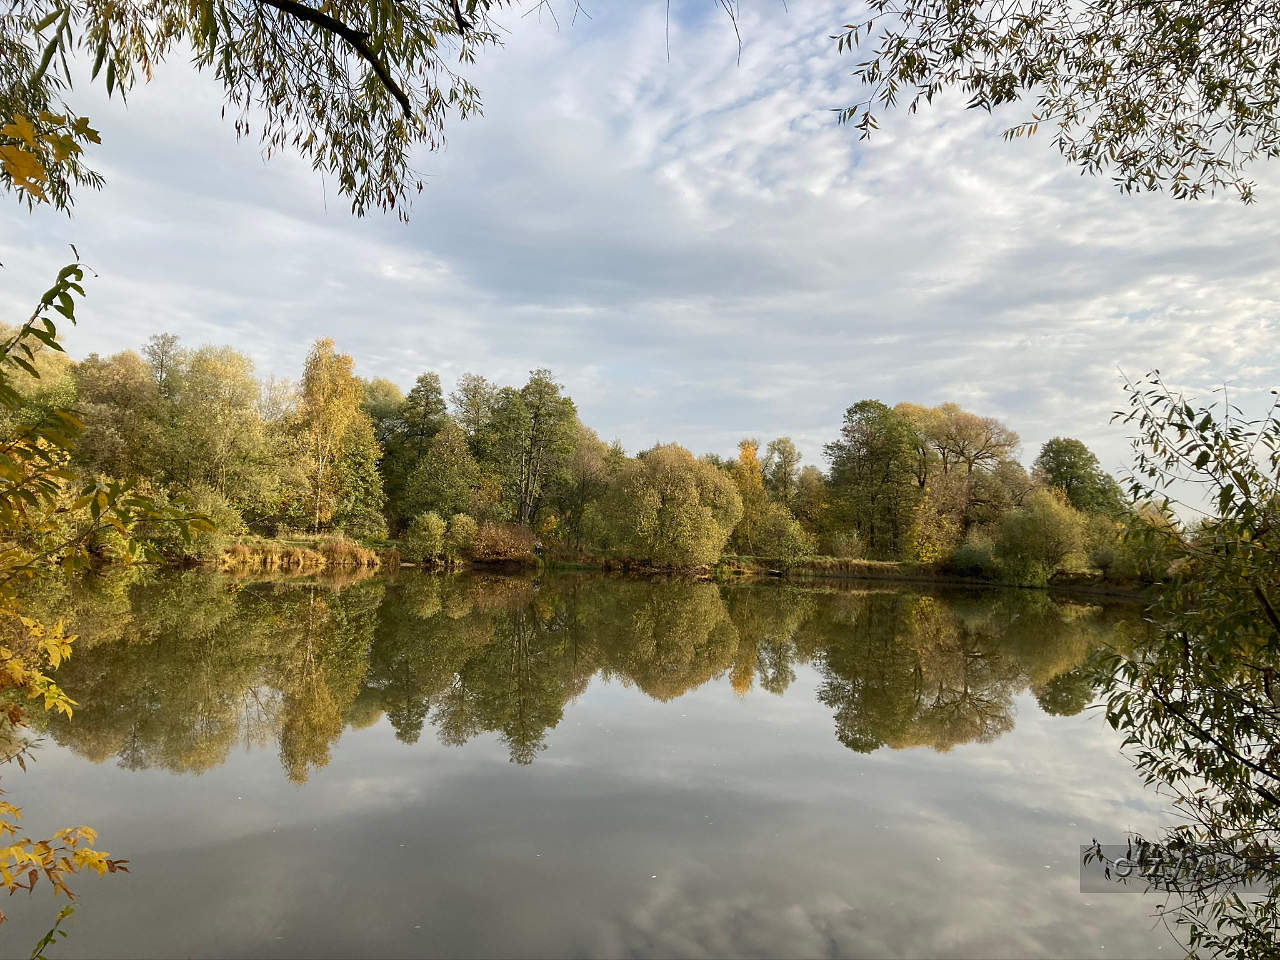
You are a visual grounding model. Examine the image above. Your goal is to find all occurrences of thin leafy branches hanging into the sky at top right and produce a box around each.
[836,0,1280,201]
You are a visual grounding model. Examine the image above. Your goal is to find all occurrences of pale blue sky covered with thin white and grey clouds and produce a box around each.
[0,0,1280,474]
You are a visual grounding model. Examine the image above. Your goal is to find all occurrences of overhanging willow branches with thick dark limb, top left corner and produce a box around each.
[0,0,506,215]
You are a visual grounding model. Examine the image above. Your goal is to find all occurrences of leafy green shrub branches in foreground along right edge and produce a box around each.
[1100,375,1280,957]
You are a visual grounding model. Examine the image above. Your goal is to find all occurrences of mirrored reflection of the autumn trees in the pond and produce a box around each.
[24,571,1135,782]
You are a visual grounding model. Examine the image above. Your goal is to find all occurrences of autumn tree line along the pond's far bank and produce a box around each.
[10,334,1158,582]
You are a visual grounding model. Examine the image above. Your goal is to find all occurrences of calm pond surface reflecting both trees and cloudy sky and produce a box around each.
[0,572,1178,957]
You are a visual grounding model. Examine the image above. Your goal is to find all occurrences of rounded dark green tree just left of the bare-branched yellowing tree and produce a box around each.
[826,399,920,559]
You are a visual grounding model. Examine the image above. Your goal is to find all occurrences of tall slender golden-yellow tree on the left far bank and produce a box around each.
[300,338,364,530]
